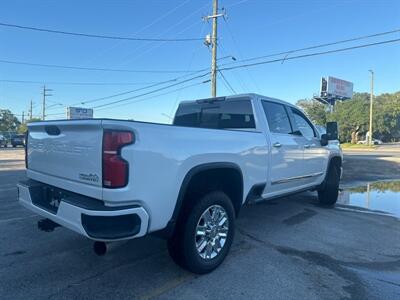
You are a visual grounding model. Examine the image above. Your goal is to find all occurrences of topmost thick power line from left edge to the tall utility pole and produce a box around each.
[0,23,203,42]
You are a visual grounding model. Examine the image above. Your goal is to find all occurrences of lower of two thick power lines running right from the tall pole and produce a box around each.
[220,39,400,71]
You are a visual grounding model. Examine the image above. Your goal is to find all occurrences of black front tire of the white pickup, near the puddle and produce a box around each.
[318,164,340,206]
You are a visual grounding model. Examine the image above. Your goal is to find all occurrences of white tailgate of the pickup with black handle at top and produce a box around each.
[27,120,103,187]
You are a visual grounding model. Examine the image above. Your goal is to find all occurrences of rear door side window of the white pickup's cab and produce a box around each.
[262,101,293,134]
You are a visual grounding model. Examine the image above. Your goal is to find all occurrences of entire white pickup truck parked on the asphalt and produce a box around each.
[18,94,342,273]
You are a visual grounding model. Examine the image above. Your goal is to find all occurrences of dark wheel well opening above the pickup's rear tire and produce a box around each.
[174,164,243,220]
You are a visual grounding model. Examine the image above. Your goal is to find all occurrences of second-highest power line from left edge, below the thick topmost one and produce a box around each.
[0,59,202,73]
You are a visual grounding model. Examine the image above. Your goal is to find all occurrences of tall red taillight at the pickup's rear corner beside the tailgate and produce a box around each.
[103,130,134,188]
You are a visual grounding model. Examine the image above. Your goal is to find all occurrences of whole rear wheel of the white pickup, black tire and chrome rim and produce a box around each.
[168,191,235,274]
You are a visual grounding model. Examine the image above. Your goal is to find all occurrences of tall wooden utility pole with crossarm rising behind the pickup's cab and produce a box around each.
[203,0,225,97]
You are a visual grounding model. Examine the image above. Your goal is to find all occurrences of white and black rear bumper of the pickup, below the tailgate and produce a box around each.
[18,180,149,241]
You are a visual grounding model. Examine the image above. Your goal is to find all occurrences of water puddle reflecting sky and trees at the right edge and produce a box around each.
[337,180,400,218]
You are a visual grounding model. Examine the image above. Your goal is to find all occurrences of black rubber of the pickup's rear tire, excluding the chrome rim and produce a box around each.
[168,191,235,274]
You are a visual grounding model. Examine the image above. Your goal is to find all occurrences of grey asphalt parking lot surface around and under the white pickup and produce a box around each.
[0,149,400,299]
